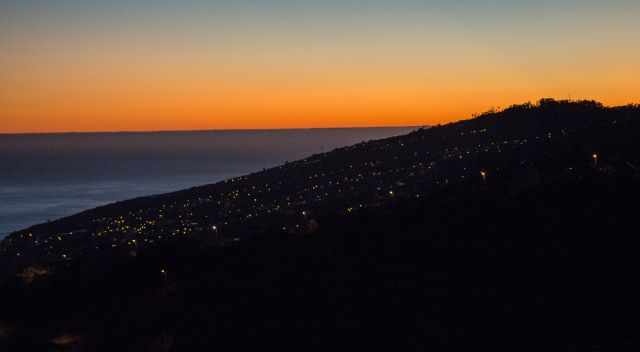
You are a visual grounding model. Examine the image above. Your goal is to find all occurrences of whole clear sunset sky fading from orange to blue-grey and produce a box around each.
[0,0,640,132]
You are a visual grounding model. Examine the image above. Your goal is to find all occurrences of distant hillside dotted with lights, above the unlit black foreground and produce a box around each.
[0,100,640,270]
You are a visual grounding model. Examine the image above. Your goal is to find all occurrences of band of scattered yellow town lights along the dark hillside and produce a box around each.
[5,129,599,264]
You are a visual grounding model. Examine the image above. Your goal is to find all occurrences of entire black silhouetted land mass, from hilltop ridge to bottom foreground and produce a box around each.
[0,101,640,351]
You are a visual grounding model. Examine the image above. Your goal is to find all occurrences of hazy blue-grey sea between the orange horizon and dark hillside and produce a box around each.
[0,127,414,239]
